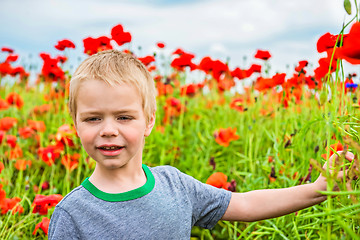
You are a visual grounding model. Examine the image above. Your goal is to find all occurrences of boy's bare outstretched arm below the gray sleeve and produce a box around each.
[222,152,354,222]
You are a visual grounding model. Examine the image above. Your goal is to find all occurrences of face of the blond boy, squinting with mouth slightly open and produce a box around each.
[75,80,155,170]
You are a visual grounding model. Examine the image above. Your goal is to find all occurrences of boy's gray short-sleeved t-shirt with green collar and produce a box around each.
[48,165,231,240]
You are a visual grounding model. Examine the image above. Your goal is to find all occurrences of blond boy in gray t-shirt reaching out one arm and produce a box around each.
[49,50,353,239]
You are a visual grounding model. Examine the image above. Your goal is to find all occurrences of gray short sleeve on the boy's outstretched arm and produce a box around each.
[178,171,231,229]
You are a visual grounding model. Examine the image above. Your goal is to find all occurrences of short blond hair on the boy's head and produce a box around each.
[69,50,156,123]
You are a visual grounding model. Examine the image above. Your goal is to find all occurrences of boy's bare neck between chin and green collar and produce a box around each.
[89,162,147,193]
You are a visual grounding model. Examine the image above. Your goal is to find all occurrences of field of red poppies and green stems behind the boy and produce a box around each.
[0,1,360,239]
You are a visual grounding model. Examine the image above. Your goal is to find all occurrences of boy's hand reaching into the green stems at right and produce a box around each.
[314,151,354,191]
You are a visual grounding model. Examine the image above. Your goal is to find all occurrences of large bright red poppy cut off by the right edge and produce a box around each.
[336,22,360,64]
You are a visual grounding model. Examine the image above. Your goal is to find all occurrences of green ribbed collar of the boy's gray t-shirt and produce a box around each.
[81,164,155,202]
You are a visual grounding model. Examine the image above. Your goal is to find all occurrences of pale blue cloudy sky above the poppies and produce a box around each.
[0,0,360,81]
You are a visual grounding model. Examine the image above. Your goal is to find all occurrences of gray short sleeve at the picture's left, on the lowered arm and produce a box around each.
[48,206,80,240]
